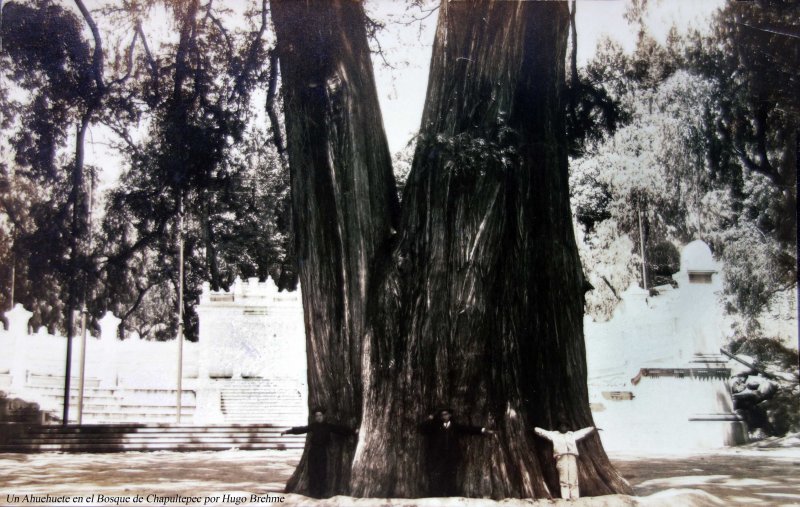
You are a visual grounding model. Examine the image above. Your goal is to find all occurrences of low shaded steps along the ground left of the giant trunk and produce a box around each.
[0,423,305,453]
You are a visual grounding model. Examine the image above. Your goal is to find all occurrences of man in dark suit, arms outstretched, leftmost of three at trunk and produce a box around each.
[281,408,358,498]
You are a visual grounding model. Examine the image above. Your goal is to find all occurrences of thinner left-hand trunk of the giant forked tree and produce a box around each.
[271,0,398,500]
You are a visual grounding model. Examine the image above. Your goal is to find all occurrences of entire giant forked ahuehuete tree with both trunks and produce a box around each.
[271,0,630,498]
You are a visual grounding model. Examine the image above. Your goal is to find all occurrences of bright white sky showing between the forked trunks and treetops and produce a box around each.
[81,0,723,188]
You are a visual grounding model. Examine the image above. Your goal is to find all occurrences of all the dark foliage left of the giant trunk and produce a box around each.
[0,0,297,339]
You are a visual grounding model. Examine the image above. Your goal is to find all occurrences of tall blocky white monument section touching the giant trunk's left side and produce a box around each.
[195,278,308,425]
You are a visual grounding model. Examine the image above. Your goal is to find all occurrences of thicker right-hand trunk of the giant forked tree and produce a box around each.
[352,1,630,498]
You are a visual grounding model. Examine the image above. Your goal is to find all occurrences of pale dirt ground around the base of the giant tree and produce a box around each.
[0,448,800,507]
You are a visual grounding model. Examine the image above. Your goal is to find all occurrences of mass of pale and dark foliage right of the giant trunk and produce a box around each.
[571,2,800,331]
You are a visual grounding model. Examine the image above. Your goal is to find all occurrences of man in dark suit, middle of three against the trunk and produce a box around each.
[420,408,494,497]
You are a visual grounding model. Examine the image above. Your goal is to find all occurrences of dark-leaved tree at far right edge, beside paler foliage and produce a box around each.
[689,1,800,324]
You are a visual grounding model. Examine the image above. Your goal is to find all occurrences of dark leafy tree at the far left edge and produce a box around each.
[2,1,105,333]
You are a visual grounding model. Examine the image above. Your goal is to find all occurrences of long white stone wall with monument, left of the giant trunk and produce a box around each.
[0,279,307,425]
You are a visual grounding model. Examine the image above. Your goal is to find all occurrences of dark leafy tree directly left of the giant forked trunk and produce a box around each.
[96,2,290,339]
